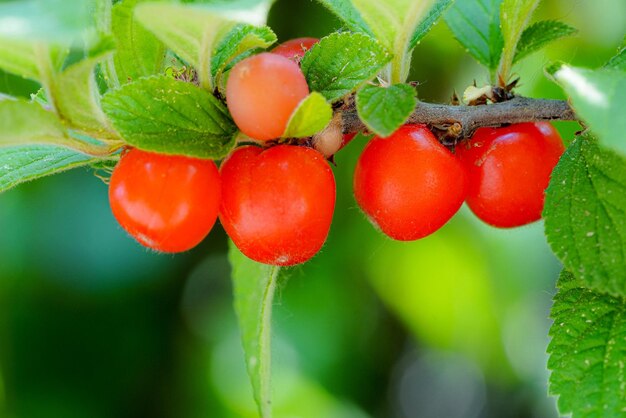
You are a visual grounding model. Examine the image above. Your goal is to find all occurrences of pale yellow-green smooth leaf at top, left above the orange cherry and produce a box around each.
[135,3,235,90]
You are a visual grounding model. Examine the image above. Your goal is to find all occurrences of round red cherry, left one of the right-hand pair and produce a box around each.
[354,125,466,241]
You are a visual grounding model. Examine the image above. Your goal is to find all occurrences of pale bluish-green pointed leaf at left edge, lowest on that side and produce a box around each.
[0,145,98,192]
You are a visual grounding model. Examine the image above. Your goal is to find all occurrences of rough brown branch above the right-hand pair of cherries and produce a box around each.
[342,97,578,144]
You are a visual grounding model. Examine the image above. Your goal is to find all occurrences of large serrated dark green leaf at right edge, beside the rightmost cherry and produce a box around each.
[543,137,626,295]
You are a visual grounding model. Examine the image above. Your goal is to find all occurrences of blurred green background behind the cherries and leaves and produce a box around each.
[0,0,626,418]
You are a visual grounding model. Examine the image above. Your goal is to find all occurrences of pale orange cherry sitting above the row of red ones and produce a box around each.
[226,52,309,141]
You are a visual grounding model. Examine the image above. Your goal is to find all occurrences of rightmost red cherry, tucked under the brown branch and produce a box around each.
[456,122,565,228]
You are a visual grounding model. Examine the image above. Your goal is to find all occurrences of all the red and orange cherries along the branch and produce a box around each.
[109,38,564,266]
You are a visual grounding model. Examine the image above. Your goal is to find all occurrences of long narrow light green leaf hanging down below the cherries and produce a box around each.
[228,242,280,418]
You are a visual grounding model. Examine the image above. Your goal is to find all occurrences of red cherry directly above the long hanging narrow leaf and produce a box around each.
[220,145,335,266]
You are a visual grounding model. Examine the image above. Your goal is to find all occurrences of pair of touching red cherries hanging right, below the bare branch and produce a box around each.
[354,122,565,241]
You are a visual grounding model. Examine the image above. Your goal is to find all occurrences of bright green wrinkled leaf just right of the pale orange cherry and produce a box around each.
[301,33,391,102]
